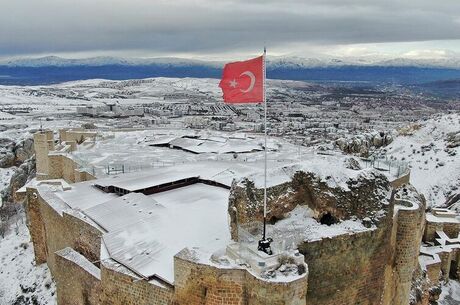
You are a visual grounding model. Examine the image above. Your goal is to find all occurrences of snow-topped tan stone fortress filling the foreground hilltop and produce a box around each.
[17,130,460,305]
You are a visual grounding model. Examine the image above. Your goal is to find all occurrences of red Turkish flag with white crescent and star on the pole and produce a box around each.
[219,56,264,104]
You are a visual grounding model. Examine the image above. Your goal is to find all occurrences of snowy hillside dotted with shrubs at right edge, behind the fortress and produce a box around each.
[387,114,460,206]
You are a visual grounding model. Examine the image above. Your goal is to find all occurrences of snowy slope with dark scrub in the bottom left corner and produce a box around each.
[0,213,56,305]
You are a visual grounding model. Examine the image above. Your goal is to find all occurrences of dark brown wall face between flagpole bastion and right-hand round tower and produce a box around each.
[299,216,393,305]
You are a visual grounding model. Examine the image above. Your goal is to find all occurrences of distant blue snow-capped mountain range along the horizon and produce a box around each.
[0,56,460,85]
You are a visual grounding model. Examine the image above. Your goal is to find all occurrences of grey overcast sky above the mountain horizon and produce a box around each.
[0,0,460,59]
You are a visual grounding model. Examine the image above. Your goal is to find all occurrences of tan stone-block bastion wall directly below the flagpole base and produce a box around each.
[174,249,310,305]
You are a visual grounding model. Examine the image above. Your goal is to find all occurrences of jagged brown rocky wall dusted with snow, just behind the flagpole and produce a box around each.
[228,166,391,239]
